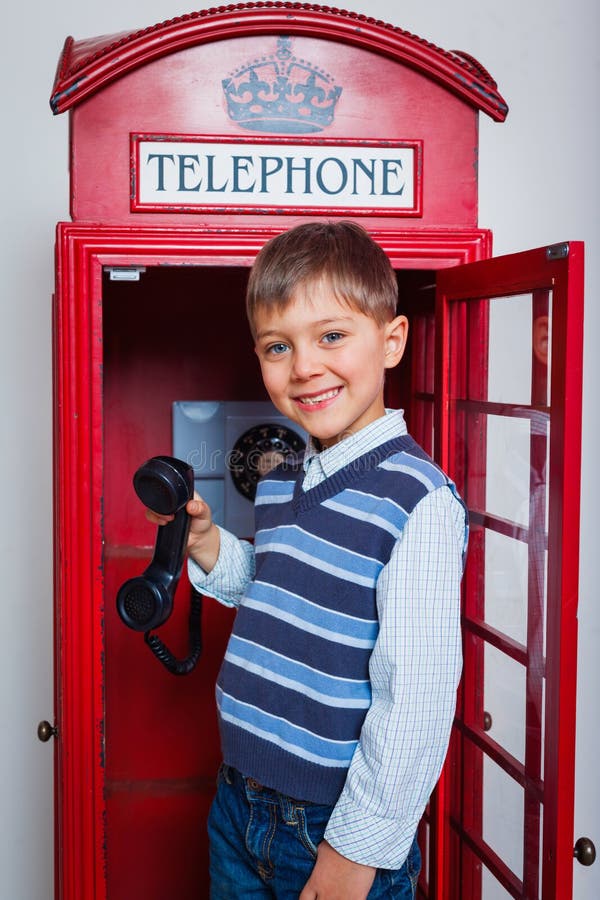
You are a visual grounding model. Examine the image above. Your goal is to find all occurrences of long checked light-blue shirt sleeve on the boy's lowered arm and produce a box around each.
[325,487,465,869]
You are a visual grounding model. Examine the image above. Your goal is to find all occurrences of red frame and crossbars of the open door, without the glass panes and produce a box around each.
[435,242,583,900]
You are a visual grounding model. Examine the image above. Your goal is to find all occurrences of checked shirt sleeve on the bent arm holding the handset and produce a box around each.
[188,526,255,606]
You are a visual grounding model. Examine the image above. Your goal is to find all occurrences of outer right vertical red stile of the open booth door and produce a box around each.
[542,243,584,898]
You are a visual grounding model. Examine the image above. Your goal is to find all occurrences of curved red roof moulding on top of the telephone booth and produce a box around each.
[50,2,508,121]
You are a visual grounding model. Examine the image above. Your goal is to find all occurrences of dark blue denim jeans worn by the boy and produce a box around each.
[208,765,421,900]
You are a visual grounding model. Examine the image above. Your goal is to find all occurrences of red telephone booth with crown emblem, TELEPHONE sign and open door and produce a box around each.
[51,3,582,900]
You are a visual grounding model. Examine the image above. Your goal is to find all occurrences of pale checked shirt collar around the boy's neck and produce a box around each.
[303,409,407,478]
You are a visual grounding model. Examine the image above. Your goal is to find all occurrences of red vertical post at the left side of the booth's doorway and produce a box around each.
[54,225,104,898]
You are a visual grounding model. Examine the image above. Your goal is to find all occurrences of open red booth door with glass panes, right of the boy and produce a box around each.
[436,243,583,900]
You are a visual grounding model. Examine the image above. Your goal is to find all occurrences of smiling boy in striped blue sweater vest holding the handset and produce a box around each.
[151,222,466,900]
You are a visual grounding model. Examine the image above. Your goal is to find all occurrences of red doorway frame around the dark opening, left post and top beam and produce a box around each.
[54,223,491,900]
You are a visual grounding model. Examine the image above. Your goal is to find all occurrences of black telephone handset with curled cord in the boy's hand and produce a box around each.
[117,456,202,675]
